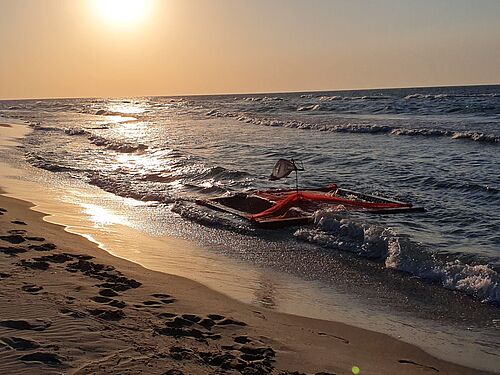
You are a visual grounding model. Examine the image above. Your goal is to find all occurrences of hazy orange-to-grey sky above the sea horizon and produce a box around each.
[0,0,500,99]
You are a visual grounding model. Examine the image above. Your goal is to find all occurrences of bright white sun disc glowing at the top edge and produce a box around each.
[94,0,150,26]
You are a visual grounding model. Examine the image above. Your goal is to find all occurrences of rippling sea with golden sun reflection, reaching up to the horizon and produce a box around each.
[0,85,500,371]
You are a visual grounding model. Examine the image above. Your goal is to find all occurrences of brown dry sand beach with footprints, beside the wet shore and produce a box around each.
[0,194,488,374]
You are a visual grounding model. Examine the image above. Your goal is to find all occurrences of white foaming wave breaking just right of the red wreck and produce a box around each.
[294,210,500,304]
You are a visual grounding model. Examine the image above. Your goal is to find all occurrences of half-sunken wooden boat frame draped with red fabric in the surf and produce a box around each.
[196,184,425,229]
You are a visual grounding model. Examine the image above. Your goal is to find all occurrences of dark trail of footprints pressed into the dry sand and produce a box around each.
[0,208,439,375]
